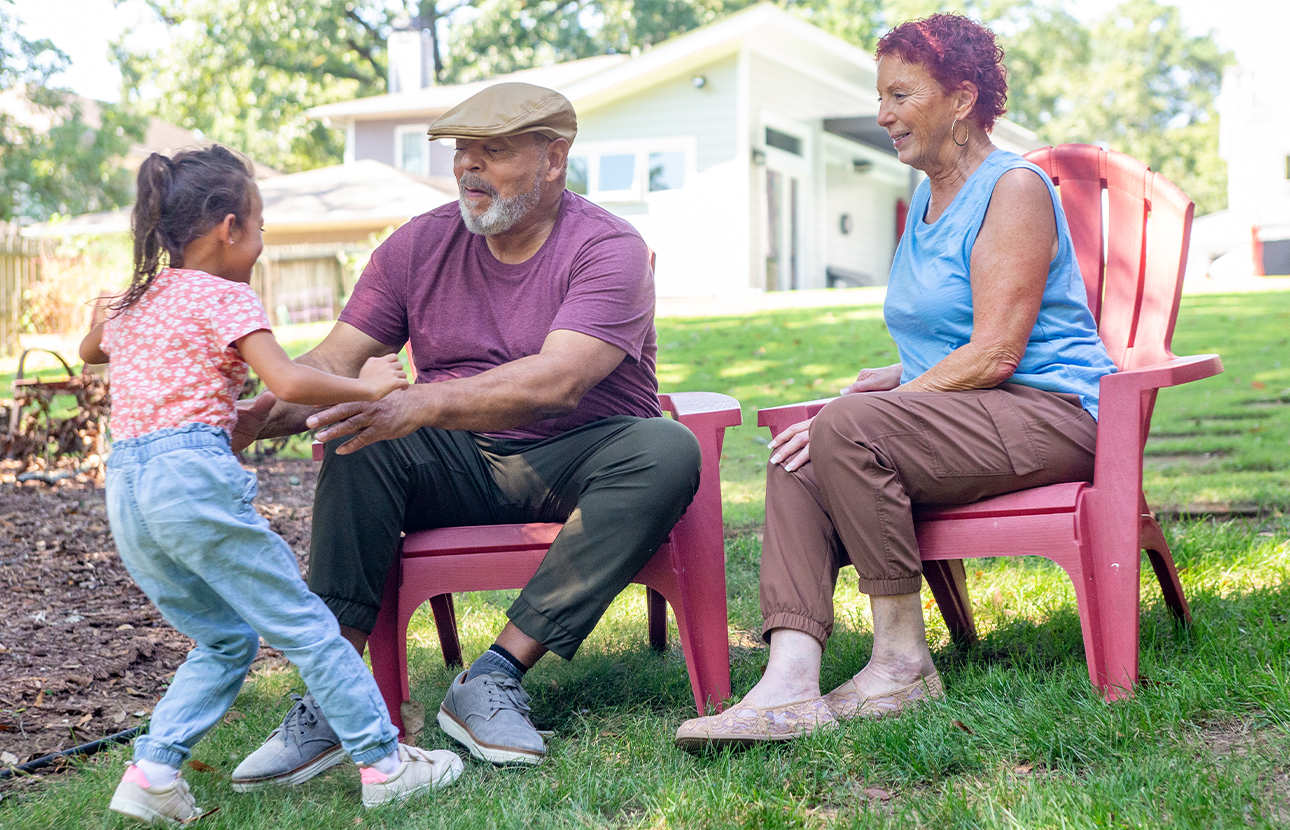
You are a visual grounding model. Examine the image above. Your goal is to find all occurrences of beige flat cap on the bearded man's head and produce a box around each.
[426,84,578,142]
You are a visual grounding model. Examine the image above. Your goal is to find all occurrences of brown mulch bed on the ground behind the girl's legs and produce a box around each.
[0,460,316,786]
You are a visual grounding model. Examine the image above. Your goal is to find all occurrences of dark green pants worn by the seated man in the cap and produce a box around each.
[308,416,702,660]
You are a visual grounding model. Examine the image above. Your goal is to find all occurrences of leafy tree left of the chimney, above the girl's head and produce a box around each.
[114,0,388,172]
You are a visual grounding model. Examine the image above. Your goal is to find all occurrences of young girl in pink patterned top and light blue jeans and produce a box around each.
[80,146,462,824]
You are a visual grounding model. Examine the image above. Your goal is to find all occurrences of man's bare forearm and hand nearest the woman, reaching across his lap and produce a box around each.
[308,329,626,453]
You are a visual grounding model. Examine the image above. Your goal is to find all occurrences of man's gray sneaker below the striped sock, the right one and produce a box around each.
[437,671,547,764]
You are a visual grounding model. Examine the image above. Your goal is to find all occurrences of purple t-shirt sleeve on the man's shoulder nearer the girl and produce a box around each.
[339,219,415,349]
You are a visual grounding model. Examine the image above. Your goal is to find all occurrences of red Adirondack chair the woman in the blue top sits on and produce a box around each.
[757,145,1223,701]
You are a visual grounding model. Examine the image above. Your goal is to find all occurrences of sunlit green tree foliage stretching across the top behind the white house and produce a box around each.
[119,0,1231,210]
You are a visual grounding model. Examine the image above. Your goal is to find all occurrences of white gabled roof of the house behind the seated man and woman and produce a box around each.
[306,3,1044,151]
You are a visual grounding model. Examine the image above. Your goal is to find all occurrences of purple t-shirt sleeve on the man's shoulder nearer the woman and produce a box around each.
[551,228,654,363]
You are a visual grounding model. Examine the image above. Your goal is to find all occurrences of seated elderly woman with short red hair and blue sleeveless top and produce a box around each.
[676,14,1115,749]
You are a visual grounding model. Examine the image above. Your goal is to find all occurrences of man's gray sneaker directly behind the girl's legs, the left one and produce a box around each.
[232,694,348,793]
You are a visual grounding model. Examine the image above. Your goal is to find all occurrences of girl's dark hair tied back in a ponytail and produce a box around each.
[111,145,254,311]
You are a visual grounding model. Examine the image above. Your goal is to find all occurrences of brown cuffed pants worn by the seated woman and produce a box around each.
[761,383,1098,643]
